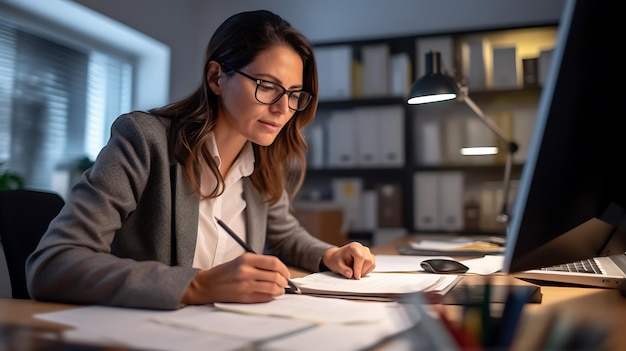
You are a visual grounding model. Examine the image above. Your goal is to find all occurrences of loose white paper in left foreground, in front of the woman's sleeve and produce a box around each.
[35,306,312,351]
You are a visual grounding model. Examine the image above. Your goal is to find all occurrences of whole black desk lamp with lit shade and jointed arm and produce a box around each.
[407,51,518,224]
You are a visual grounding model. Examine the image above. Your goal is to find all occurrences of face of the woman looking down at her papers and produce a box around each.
[217,46,304,146]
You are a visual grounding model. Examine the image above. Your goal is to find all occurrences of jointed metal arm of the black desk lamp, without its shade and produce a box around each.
[459,86,518,224]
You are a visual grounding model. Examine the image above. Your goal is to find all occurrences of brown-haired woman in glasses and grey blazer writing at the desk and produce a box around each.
[27,11,375,309]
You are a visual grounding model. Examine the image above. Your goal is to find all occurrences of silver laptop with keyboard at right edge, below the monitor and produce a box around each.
[513,254,626,293]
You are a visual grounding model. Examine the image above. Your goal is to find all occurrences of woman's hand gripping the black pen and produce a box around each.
[181,253,289,305]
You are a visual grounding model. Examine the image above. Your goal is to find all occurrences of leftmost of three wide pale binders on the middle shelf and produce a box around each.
[326,110,357,168]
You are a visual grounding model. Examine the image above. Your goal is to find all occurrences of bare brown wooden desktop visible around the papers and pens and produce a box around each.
[0,235,626,350]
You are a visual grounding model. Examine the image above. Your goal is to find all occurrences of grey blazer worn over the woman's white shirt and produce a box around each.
[26,112,332,309]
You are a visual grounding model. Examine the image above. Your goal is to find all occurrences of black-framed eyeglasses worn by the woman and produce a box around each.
[227,69,313,111]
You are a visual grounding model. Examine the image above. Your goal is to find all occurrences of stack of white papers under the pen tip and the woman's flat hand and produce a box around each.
[292,272,460,299]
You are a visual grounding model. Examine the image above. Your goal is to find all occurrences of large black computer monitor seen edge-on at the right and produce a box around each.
[503,0,626,273]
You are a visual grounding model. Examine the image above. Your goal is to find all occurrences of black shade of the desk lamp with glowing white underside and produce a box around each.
[407,51,457,105]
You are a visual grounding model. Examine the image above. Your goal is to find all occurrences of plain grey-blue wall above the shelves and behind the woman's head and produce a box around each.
[74,0,566,103]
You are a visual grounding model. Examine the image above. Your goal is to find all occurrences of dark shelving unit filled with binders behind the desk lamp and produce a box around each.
[295,23,557,246]
